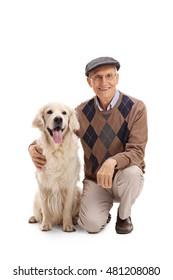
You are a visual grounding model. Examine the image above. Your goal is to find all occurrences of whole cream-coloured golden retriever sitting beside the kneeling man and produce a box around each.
[29,103,81,232]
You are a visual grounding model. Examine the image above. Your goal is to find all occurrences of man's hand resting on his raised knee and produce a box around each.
[97,158,117,189]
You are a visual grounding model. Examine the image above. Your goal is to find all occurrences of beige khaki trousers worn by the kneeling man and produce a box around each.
[78,165,144,233]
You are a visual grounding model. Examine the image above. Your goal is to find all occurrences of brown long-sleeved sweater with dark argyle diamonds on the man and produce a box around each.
[76,92,147,180]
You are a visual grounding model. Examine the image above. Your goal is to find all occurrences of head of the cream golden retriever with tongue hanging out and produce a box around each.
[32,103,79,144]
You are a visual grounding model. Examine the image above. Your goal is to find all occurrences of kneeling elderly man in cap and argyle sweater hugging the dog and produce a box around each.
[29,57,148,234]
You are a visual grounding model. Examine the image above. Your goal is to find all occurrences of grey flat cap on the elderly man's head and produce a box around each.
[85,56,120,77]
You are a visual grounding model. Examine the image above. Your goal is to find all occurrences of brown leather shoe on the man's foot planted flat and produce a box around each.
[115,214,133,234]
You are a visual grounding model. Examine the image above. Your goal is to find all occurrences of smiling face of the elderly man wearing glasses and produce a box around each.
[87,65,119,103]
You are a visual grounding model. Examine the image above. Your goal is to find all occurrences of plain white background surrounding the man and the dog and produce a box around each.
[0,0,173,280]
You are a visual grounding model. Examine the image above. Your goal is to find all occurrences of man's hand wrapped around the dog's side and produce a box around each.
[29,144,46,169]
